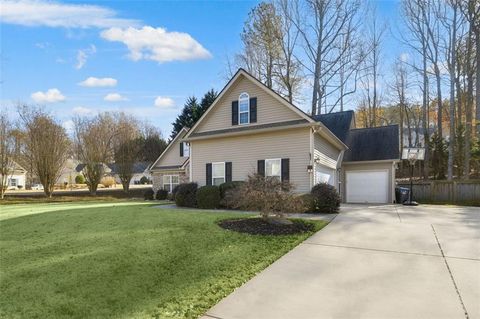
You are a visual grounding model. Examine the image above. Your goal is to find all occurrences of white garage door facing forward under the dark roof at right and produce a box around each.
[346,170,388,203]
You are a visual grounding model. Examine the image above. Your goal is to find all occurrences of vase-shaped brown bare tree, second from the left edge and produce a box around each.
[19,106,71,197]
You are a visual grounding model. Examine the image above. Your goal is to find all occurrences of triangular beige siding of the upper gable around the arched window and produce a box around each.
[195,75,302,133]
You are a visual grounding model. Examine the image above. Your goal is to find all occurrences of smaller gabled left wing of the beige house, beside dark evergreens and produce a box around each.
[150,128,190,192]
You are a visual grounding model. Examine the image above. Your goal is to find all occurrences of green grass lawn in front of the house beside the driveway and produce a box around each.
[0,202,325,318]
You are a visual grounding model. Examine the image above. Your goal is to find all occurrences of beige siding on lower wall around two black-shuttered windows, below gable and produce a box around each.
[191,128,311,192]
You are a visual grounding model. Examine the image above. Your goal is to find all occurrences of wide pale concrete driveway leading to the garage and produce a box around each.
[204,205,480,319]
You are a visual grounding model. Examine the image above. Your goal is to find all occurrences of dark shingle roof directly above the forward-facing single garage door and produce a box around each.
[343,125,400,162]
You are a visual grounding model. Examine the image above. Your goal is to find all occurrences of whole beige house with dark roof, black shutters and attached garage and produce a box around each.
[151,69,399,203]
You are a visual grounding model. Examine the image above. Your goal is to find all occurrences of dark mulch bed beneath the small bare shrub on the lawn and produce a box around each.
[218,218,315,235]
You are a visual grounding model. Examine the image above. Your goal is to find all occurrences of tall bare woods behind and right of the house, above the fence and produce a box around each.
[227,0,480,180]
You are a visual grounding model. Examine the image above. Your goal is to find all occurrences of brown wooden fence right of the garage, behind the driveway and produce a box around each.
[398,179,480,205]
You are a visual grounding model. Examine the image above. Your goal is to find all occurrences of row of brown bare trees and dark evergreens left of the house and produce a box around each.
[0,89,218,198]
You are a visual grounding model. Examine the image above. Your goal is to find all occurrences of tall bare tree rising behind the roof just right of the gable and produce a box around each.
[291,0,360,114]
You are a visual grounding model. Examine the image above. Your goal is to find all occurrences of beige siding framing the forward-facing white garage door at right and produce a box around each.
[341,162,395,203]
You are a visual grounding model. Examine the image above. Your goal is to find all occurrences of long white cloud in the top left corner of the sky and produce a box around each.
[0,0,138,28]
